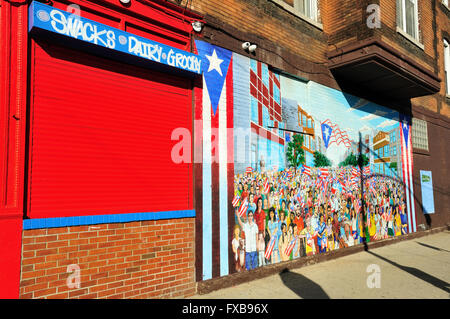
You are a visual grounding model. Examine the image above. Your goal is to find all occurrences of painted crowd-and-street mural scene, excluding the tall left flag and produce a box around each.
[230,54,415,272]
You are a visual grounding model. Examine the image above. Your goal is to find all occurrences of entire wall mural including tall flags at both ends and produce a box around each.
[194,41,416,279]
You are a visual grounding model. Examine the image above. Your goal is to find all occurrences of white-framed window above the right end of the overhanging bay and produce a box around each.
[397,0,419,40]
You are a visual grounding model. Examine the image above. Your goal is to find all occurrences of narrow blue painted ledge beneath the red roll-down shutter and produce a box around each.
[23,209,195,230]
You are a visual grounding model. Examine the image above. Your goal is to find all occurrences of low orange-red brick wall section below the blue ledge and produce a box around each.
[20,218,196,298]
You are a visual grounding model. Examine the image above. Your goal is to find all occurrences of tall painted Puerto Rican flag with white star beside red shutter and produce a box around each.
[194,40,234,280]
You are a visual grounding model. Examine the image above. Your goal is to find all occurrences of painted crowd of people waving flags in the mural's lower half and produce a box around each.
[231,166,407,271]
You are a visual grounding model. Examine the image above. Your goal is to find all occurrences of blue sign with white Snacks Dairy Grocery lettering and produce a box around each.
[29,1,202,74]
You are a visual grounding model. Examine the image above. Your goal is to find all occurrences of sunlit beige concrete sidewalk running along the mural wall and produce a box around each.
[193,231,450,299]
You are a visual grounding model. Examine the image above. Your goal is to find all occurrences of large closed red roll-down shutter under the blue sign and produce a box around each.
[28,43,192,218]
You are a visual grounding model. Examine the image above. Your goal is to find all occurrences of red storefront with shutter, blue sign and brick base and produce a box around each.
[1,1,201,298]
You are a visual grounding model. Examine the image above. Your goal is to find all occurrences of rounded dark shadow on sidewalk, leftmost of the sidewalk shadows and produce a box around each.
[279,268,330,299]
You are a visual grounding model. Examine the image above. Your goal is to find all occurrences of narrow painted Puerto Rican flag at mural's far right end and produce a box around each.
[399,114,417,233]
